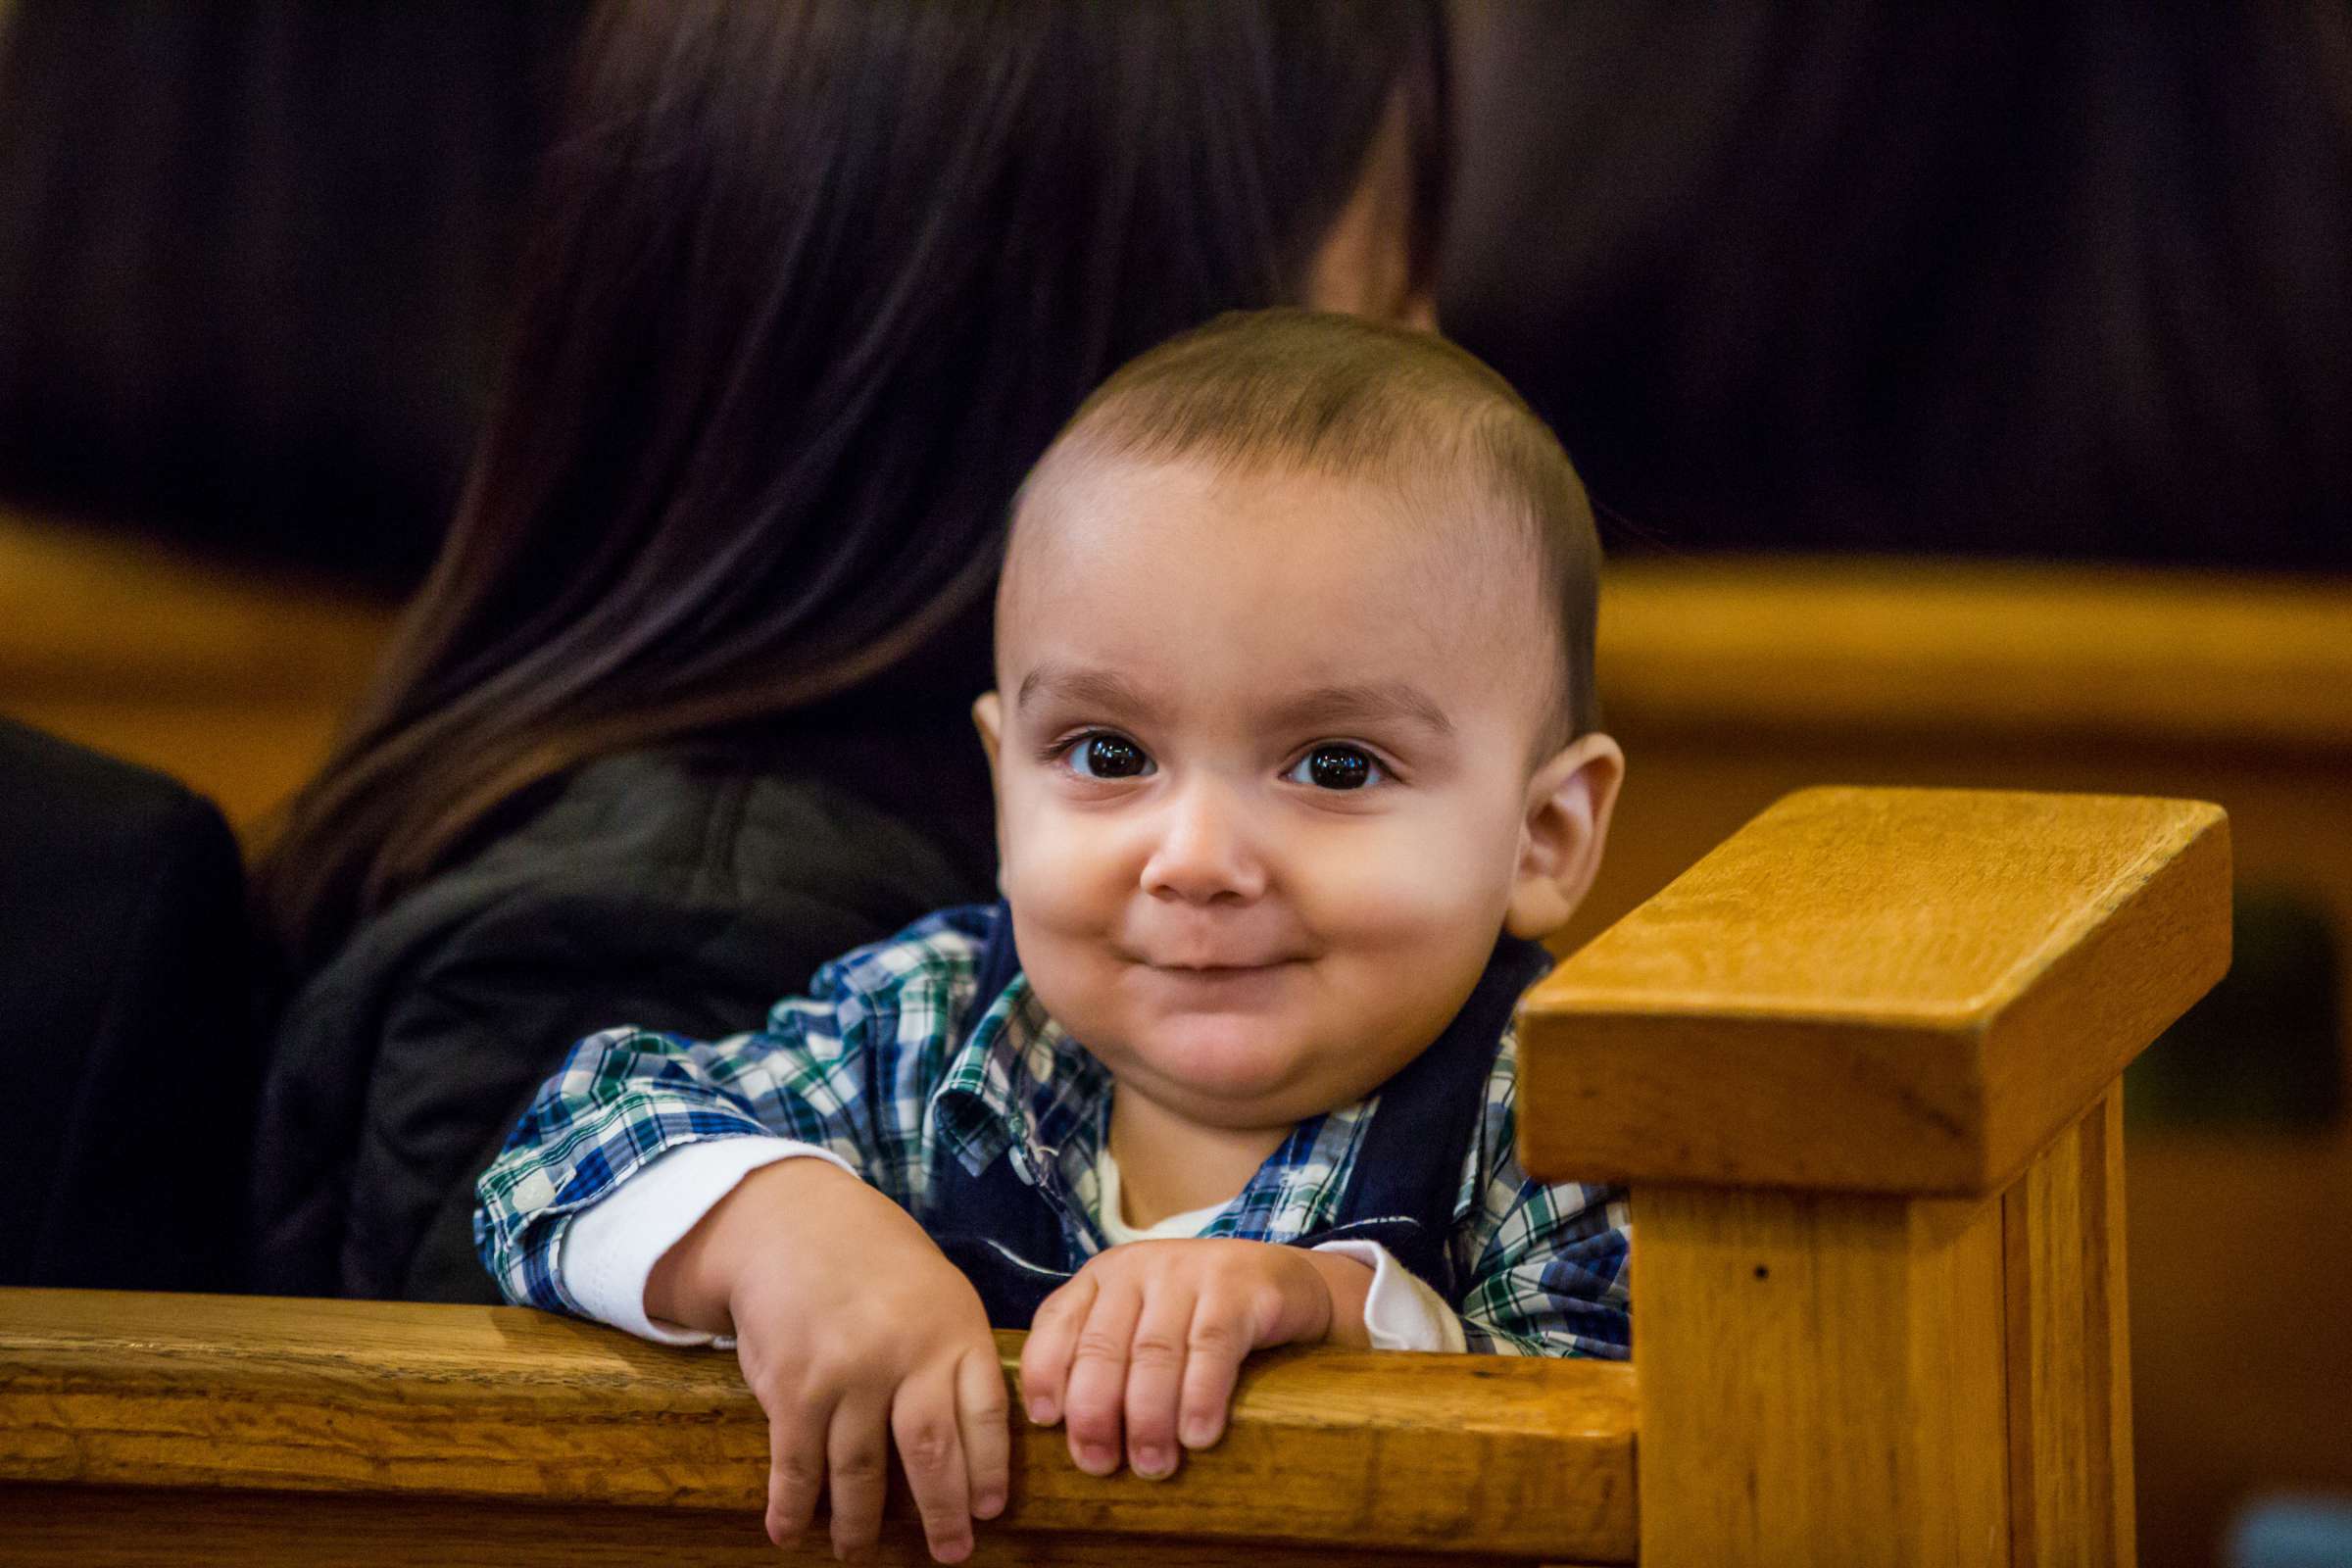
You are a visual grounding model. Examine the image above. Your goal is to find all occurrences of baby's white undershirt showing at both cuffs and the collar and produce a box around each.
[555,1138,1465,1351]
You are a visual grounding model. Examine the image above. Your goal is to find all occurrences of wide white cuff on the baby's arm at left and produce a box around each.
[558,1138,857,1348]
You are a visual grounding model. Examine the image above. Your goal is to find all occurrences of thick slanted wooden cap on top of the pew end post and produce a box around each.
[1519,788,2230,1197]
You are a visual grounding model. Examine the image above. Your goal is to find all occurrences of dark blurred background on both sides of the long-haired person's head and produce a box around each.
[0,0,2352,590]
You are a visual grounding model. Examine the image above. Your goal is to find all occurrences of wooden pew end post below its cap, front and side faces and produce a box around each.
[1633,1091,2135,1568]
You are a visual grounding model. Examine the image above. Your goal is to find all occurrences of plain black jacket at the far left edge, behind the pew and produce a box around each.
[0,719,261,1291]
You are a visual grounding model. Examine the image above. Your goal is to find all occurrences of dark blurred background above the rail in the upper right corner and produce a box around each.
[1445,0,2352,569]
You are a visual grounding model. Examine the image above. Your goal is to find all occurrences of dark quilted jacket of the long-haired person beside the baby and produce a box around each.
[254,714,995,1302]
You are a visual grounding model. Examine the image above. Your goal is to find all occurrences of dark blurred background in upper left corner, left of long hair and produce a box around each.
[0,0,581,592]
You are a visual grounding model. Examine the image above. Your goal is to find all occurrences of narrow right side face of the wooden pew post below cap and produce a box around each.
[2001,1091,2138,1568]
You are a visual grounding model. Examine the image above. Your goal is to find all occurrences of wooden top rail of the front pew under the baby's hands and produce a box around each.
[0,1291,1635,1561]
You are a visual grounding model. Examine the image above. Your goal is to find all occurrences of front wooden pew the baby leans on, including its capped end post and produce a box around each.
[0,790,2230,1566]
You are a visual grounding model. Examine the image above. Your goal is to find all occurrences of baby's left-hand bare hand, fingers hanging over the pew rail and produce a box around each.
[647,1159,1011,1563]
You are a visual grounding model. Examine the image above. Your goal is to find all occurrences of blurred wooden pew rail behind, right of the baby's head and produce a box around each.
[1594,558,2352,757]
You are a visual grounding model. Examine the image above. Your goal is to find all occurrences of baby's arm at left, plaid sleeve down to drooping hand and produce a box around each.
[475,921,1006,1561]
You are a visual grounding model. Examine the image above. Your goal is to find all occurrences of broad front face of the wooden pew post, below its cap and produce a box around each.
[1633,1187,2009,1568]
